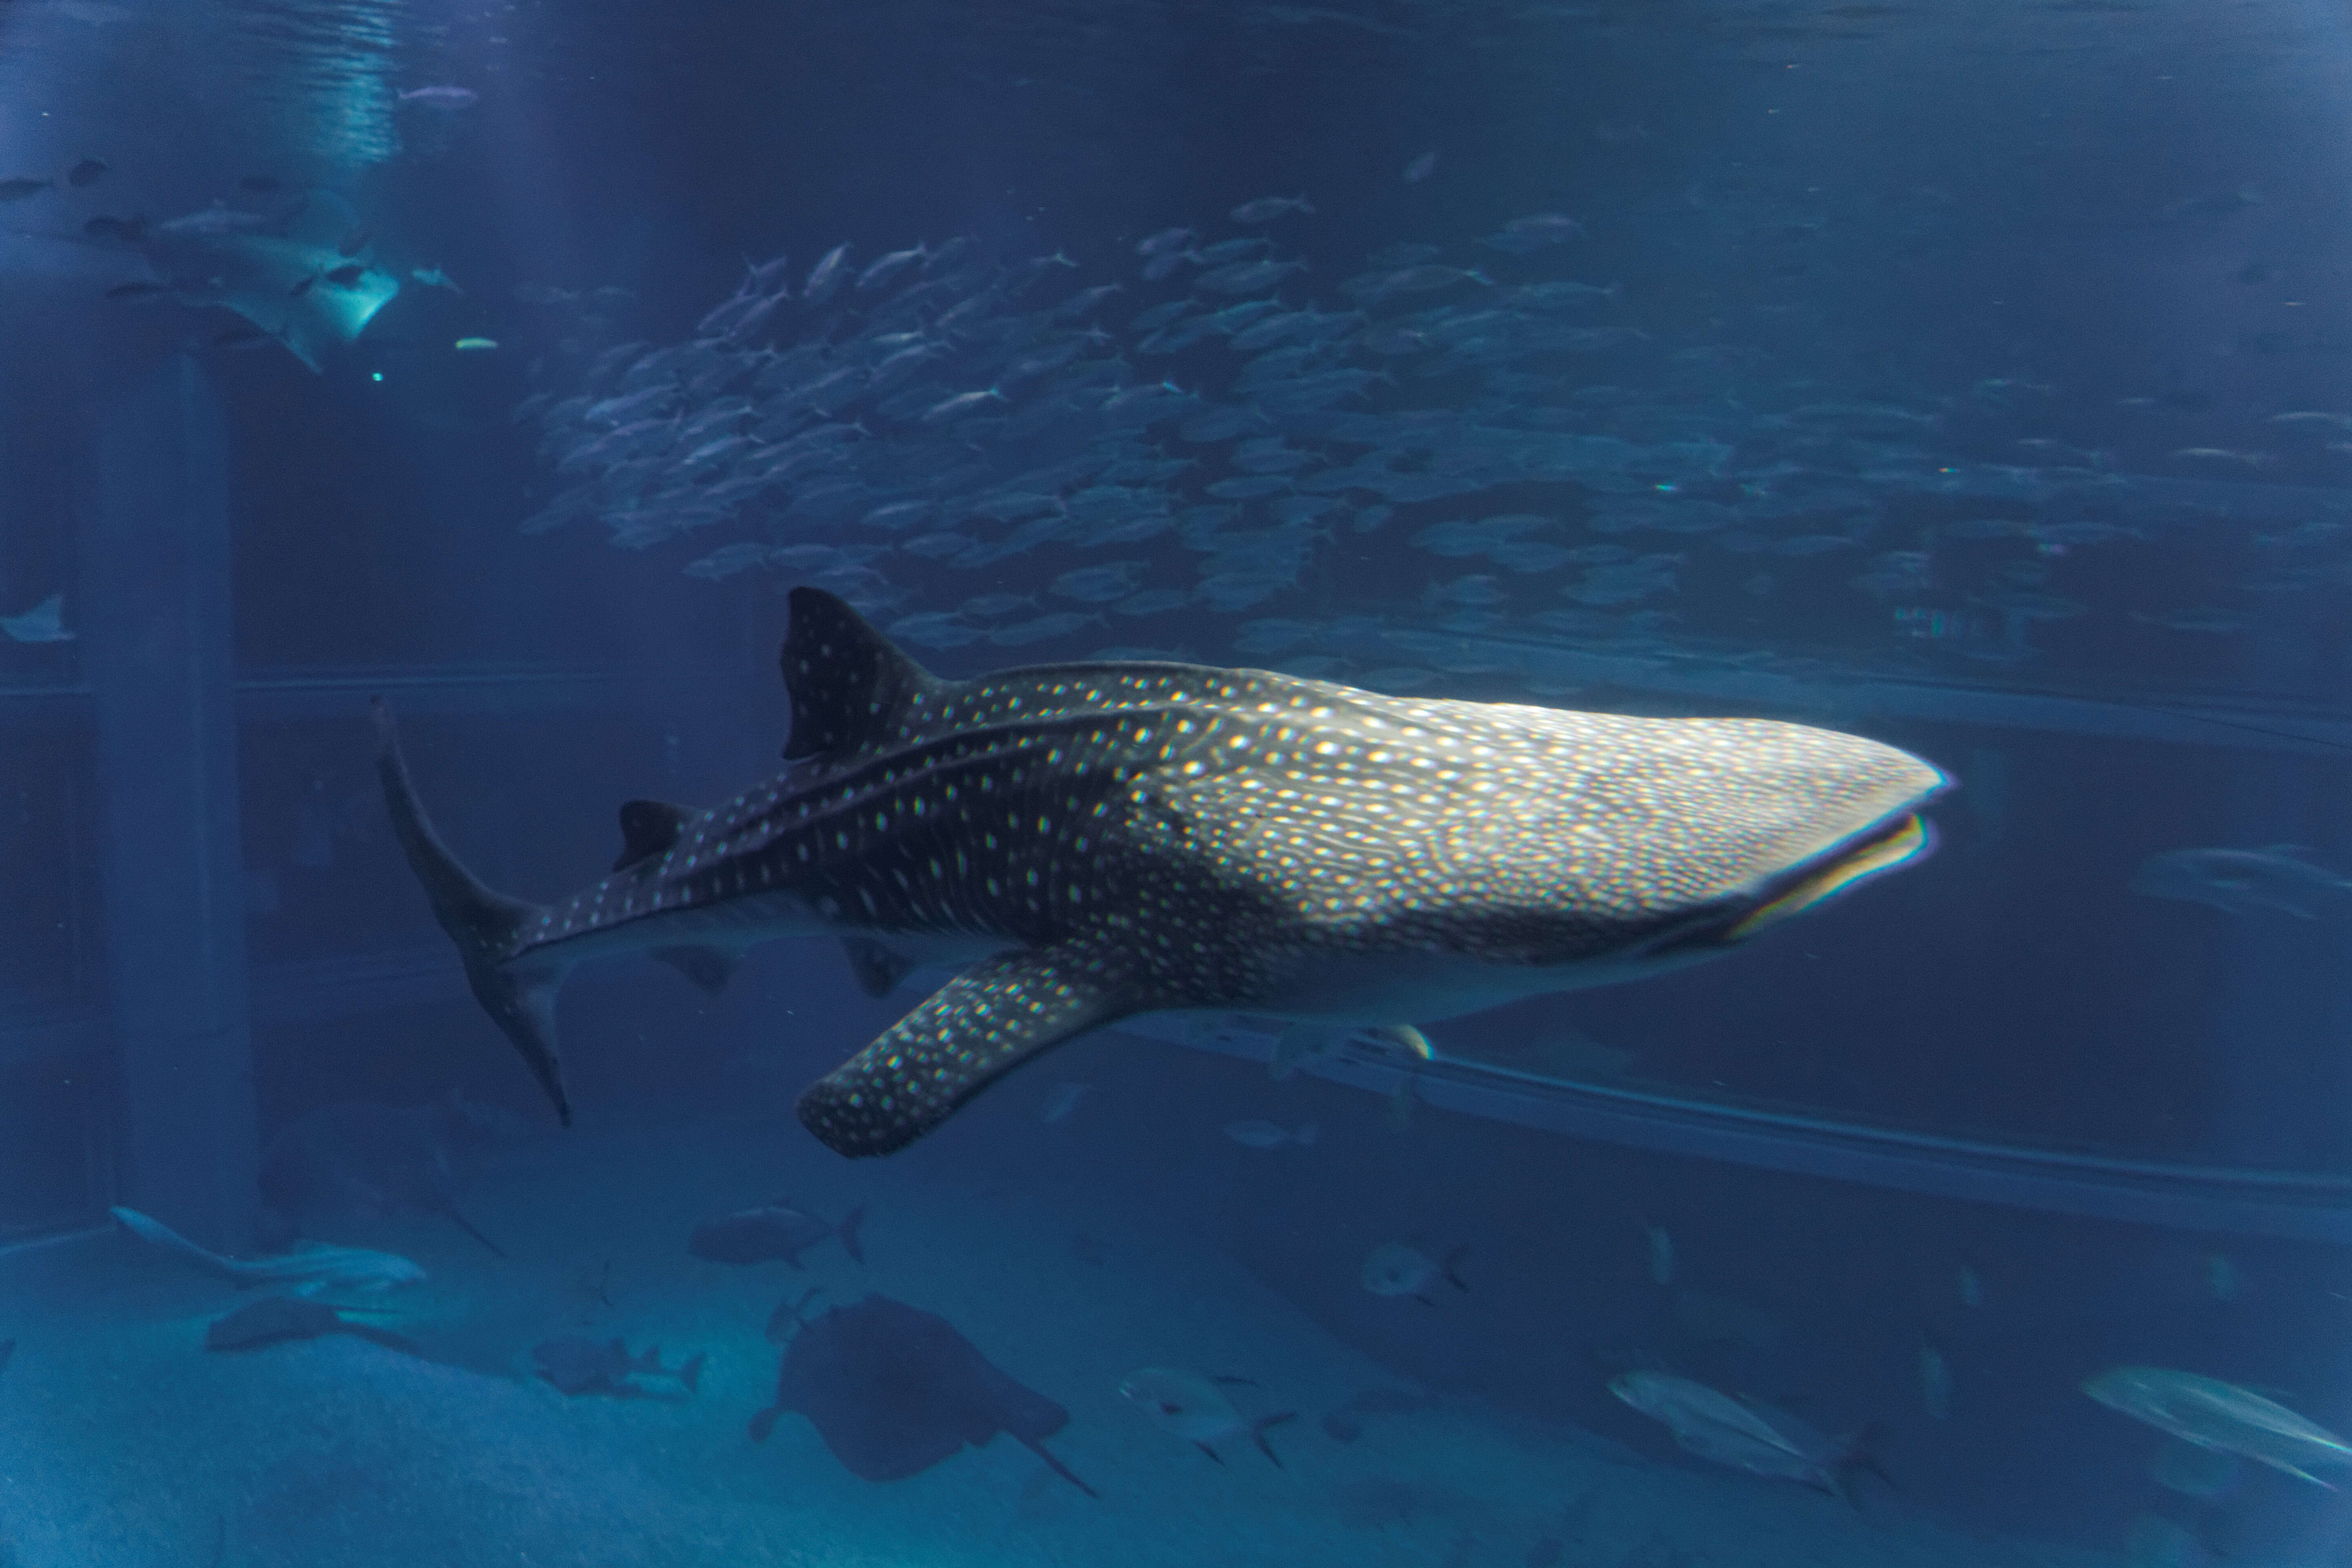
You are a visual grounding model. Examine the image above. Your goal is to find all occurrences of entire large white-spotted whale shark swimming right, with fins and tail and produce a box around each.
[376,588,1945,1157]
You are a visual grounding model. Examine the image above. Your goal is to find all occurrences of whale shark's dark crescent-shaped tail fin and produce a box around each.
[369,698,572,1126]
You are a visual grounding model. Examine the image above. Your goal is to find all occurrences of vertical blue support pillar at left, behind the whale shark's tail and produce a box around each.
[80,355,259,1251]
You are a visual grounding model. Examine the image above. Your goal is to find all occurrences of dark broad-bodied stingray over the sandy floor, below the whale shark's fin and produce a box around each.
[750,1295,1101,1497]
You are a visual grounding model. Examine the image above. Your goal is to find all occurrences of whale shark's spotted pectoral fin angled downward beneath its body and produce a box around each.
[800,947,1162,1159]
